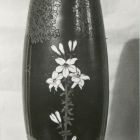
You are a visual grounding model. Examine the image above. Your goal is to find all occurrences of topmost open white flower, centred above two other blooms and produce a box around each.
[55,58,78,78]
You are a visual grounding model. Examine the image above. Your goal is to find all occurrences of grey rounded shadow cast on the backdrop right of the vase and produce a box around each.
[106,39,139,140]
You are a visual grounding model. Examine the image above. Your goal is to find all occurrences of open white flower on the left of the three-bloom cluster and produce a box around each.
[46,71,65,91]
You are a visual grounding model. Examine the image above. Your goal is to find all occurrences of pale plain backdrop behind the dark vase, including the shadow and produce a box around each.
[0,0,139,140]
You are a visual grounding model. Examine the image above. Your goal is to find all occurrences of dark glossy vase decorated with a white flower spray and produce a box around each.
[23,0,108,140]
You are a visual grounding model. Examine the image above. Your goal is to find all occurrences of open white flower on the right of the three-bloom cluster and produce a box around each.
[70,68,90,89]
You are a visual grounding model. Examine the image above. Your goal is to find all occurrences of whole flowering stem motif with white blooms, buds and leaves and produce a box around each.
[46,40,90,140]
